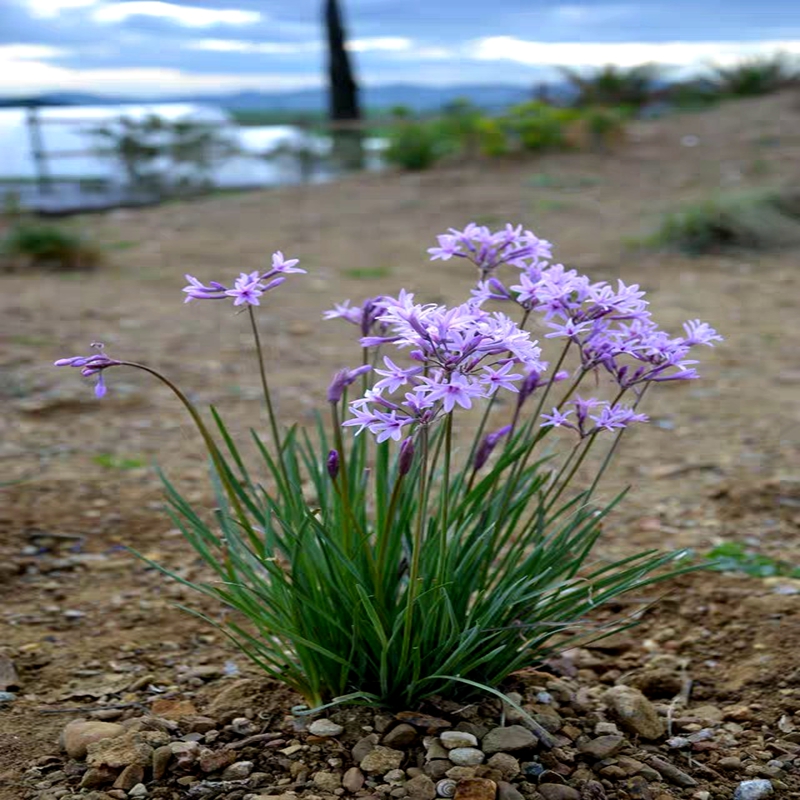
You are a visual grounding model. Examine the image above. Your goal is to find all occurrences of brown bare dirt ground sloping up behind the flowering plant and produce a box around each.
[0,96,800,798]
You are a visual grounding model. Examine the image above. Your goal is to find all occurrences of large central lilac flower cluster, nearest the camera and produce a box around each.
[343,295,547,442]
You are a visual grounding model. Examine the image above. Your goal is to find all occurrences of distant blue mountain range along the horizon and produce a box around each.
[0,84,532,112]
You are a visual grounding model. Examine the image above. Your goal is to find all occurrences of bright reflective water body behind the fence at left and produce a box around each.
[0,103,382,213]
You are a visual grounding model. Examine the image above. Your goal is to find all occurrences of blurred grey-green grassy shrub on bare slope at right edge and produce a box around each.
[649,190,800,255]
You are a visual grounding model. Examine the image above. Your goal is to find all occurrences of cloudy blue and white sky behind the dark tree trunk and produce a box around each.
[0,0,800,97]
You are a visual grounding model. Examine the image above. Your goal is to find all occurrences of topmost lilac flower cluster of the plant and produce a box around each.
[428,222,552,278]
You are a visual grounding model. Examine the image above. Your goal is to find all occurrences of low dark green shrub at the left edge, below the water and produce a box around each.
[0,221,102,270]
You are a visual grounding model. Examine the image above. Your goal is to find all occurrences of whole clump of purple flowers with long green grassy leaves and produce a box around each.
[56,224,721,712]
